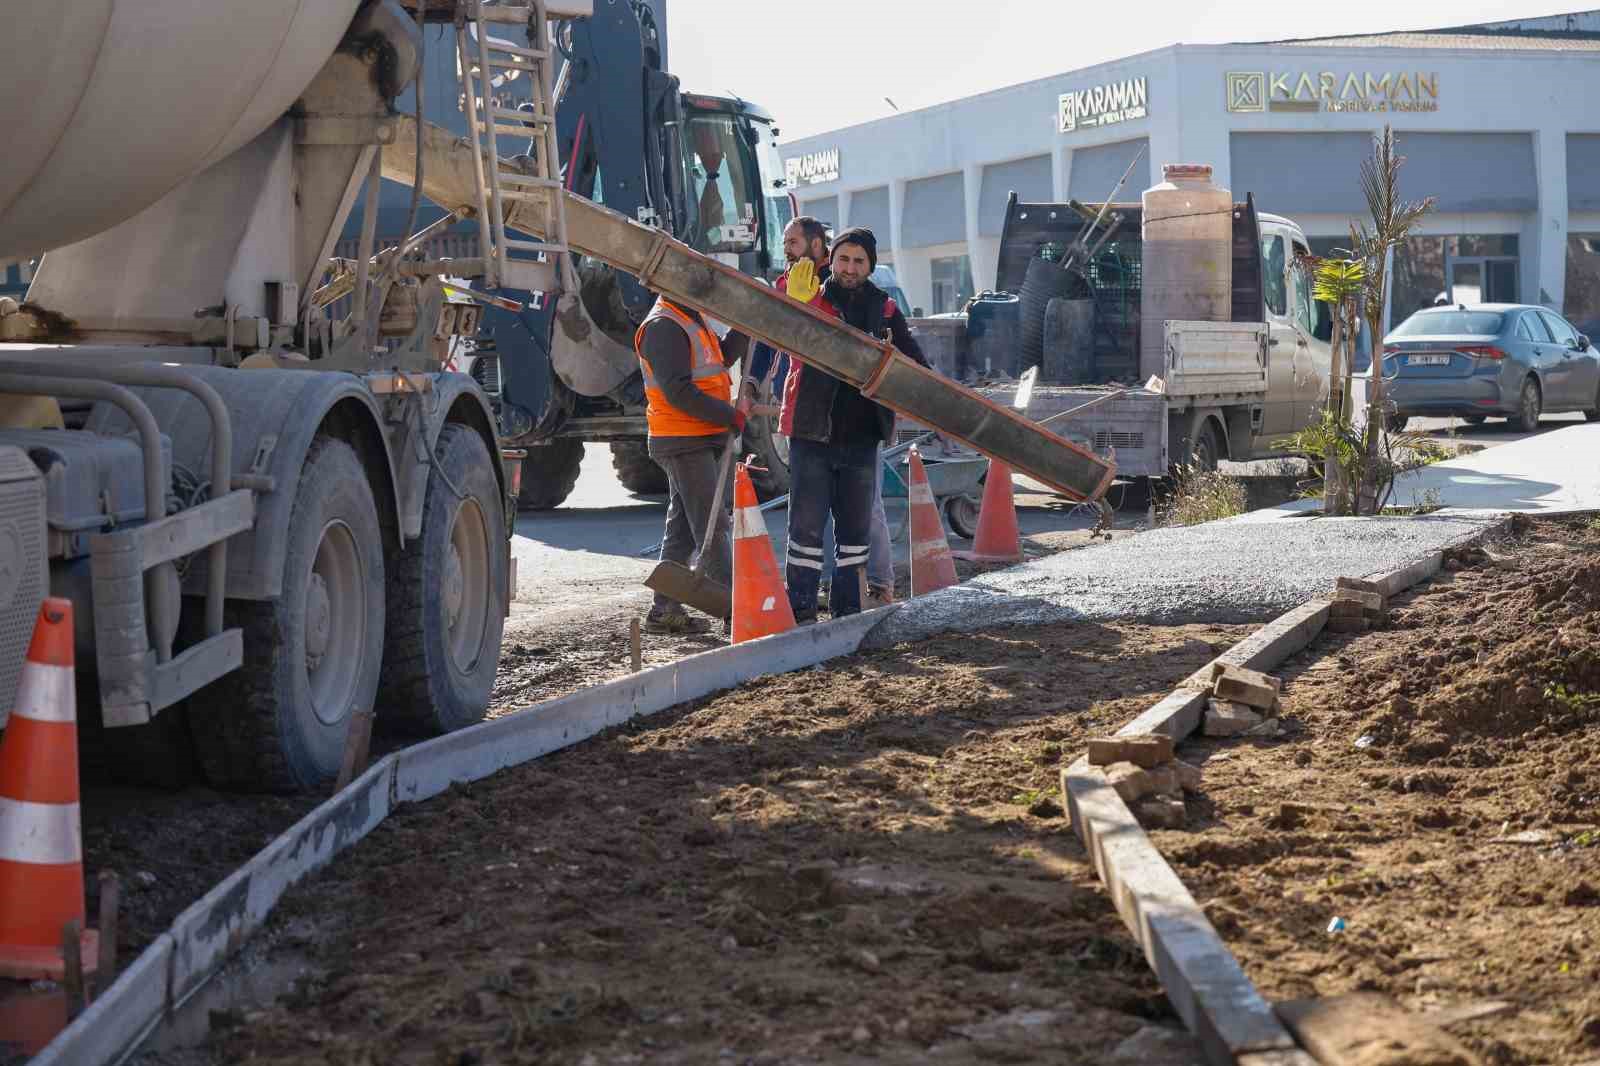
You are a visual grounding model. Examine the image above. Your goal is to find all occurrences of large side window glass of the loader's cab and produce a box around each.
[683,112,760,253]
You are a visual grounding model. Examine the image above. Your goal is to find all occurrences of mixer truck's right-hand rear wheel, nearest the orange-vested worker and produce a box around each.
[378,424,506,735]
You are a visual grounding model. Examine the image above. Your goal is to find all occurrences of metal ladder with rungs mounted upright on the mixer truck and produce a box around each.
[456,0,578,293]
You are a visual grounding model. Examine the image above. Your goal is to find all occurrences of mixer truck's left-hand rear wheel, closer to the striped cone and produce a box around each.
[189,437,384,792]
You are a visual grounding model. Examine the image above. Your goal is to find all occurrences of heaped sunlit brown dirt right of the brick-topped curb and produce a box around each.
[1154,519,1600,1064]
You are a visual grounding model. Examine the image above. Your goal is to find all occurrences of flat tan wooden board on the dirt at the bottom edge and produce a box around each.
[1275,992,1483,1066]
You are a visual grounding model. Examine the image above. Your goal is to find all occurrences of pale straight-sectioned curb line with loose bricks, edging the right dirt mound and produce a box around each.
[1061,519,1510,1066]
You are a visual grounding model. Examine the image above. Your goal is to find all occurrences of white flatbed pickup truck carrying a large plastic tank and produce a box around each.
[974,194,1331,477]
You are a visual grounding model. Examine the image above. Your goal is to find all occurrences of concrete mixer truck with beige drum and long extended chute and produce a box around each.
[0,0,1112,789]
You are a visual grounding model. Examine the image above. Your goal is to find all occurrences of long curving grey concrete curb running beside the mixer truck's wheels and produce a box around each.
[30,603,899,1066]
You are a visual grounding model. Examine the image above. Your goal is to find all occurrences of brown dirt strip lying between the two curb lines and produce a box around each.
[162,614,1245,1066]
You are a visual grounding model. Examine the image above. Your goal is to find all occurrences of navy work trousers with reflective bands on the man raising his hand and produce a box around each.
[784,439,878,621]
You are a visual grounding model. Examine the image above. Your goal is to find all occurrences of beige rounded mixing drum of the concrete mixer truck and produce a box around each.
[0,0,358,262]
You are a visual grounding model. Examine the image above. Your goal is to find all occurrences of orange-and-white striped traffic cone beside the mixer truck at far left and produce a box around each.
[0,599,98,981]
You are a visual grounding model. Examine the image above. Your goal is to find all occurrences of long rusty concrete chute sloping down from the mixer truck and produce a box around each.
[382,117,1115,499]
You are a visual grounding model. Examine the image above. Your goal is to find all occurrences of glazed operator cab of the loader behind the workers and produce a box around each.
[678,93,794,280]
